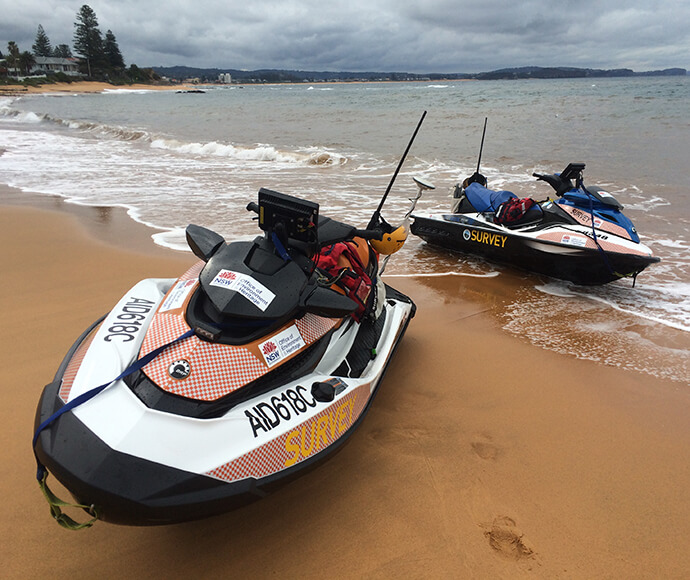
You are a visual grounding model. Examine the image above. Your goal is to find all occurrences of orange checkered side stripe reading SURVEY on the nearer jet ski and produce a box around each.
[205,384,369,482]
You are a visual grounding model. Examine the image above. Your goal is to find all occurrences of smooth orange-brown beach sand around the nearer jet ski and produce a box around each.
[0,186,690,579]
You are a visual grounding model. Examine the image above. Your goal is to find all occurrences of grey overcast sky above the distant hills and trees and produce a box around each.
[0,0,690,73]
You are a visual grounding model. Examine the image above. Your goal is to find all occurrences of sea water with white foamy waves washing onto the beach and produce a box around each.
[0,77,690,384]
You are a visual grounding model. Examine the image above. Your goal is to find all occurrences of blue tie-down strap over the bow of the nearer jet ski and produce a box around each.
[32,329,194,529]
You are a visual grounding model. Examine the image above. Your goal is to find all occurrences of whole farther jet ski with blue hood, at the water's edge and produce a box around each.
[411,163,659,285]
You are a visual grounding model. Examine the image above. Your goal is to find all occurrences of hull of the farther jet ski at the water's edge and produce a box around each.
[411,214,659,286]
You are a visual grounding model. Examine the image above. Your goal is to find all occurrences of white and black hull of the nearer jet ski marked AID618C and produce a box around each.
[35,280,415,525]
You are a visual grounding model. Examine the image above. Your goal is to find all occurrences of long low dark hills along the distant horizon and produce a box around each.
[152,66,687,83]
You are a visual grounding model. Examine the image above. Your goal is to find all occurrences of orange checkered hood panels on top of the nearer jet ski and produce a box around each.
[140,313,338,401]
